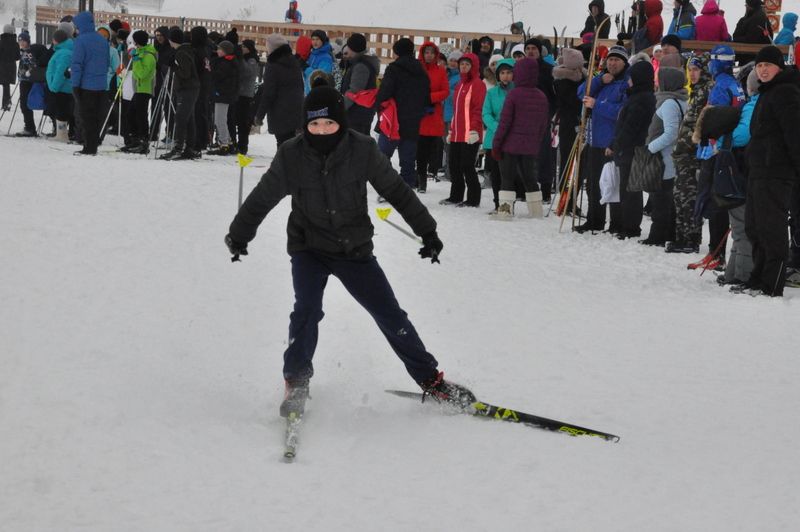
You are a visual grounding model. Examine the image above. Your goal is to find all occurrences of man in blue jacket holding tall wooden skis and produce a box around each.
[575,46,628,233]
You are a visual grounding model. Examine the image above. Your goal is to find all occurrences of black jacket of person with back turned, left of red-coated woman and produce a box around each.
[375,56,431,140]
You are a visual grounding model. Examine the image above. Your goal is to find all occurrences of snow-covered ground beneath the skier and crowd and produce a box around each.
[0,105,800,532]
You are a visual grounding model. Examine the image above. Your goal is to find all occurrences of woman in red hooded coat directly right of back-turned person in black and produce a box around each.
[417,42,450,193]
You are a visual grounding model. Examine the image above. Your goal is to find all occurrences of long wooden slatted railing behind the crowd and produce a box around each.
[36,6,511,63]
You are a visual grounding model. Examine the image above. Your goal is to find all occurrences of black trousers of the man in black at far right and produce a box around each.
[745,179,792,296]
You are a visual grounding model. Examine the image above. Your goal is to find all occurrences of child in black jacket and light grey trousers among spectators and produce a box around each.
[208,41,239,155]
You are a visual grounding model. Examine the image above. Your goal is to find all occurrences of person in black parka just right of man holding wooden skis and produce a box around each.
[606,61,656,239]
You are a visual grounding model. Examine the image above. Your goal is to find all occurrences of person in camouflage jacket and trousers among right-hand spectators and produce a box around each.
[666,53,714,253]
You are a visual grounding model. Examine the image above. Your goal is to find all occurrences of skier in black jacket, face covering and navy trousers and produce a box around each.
[225,86,475,417]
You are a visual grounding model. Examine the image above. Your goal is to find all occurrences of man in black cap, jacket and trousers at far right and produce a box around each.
[744,46,800,296]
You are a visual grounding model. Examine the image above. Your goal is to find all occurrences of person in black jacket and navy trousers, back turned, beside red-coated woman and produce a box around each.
[376,38,433,188]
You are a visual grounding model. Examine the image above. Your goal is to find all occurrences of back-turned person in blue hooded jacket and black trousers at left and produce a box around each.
[70,11,109,155]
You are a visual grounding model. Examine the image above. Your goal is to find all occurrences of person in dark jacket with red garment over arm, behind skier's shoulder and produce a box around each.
[342,33,380,135]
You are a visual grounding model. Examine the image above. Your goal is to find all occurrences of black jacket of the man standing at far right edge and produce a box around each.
[747,67,800,182]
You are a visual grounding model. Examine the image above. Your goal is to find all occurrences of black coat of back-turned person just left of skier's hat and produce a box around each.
[256,44,305,135]
